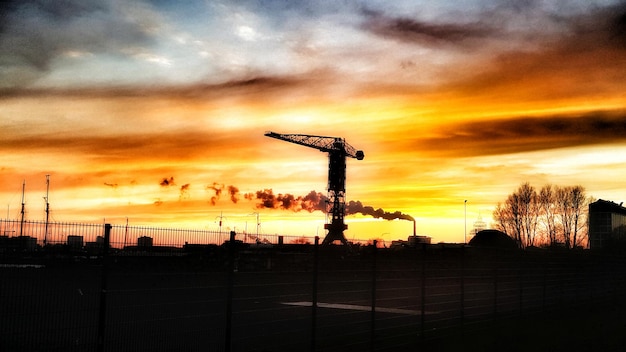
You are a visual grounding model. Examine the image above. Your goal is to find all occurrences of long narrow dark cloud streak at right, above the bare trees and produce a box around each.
[411,111,626,156]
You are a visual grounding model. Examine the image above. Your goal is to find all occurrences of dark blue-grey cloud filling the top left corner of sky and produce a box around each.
[0,0,158,87]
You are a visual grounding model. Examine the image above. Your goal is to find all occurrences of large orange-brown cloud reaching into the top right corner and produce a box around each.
[443,5,626,102]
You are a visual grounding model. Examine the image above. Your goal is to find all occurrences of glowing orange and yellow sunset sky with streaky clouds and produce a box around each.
[0,0,626,242]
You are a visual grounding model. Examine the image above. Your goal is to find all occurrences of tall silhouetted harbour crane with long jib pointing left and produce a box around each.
[265,132,365,244]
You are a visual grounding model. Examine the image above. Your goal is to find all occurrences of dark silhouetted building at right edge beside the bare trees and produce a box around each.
[589,199,626,249]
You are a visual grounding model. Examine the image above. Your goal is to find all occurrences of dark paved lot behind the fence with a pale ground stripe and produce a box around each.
[0,249,624,351]
